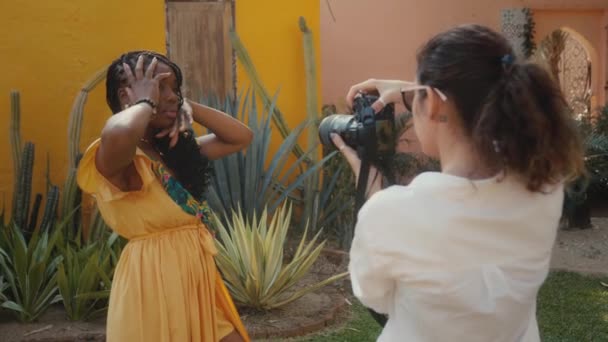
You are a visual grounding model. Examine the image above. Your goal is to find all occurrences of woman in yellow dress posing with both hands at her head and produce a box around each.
[78,51,253,342]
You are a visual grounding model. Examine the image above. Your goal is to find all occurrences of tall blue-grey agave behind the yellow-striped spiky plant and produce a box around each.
[202,93,335,223]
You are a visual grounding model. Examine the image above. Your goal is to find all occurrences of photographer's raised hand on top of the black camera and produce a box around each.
[346,78,409,113]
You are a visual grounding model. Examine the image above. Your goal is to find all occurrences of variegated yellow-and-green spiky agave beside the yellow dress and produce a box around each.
[216,203,348,310]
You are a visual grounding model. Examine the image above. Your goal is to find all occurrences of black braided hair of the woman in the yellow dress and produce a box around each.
[106,51,211,200]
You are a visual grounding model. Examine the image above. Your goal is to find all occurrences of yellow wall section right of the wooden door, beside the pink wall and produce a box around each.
[236,0,321,151]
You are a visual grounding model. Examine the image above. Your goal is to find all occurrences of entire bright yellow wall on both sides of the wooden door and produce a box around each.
[0,0,320,212]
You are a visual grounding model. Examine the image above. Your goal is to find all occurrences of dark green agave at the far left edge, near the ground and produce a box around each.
[0,220,62,322]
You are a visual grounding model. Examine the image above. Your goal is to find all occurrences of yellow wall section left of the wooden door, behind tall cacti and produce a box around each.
[0,0,165,211]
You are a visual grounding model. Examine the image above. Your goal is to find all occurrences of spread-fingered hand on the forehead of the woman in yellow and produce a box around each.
[123,55,171,104]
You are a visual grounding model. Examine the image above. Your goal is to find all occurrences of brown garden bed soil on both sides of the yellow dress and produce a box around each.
[0,250,348,342]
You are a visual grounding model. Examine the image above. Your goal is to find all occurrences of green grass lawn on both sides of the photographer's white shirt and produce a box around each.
[290,272,608,342]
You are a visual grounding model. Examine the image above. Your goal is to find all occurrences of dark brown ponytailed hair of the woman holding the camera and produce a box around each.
[417,25,584,191]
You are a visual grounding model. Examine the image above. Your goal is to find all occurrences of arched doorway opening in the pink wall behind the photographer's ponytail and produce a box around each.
[534,27,595,117]
